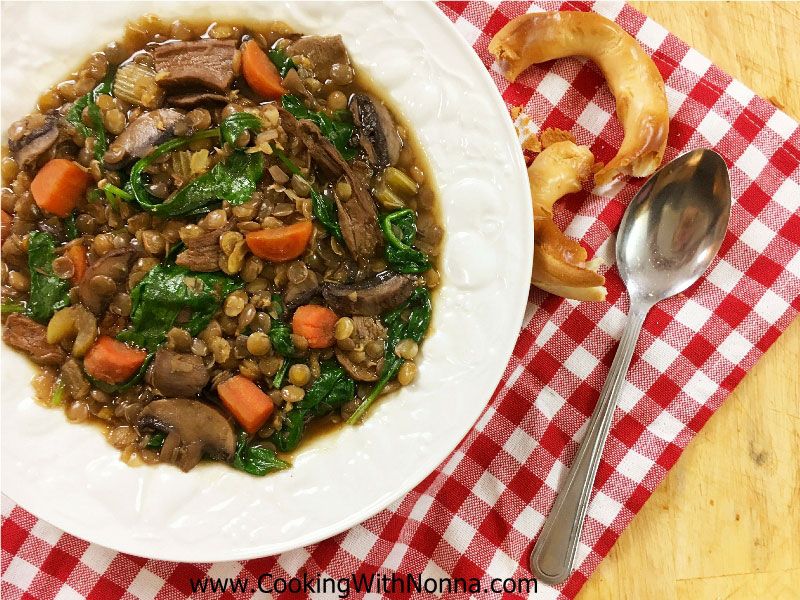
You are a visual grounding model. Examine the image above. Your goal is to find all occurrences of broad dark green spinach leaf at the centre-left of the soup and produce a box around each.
[117,263,242,352]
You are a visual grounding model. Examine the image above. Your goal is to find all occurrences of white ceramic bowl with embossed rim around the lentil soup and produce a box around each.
[2,2,533,561]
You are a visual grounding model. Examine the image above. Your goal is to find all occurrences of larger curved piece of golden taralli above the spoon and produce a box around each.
[489,11,669,185]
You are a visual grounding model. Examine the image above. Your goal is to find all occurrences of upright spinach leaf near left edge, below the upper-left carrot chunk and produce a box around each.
[27,231,70,323]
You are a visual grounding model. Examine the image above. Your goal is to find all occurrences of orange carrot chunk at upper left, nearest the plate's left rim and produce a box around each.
[31,158,92,218]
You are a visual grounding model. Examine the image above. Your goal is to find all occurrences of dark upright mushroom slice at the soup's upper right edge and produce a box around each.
[350,93,403,169]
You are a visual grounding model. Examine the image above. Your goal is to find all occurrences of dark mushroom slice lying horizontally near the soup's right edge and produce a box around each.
[322,271,415,317]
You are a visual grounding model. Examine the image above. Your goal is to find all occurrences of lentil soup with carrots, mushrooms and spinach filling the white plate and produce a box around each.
[2,16,443,475]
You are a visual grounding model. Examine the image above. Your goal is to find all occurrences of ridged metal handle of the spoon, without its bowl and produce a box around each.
[531,304,650,584]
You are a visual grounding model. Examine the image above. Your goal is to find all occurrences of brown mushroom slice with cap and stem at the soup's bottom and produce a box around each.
[136,398,236,471]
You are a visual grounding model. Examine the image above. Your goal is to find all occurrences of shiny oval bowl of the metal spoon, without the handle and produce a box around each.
[617,149,731,303]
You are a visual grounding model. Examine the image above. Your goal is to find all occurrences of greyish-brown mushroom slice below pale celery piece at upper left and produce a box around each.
[103,108,189,169]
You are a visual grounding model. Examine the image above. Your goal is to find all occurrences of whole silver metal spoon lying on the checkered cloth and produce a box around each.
[531,149,731,584]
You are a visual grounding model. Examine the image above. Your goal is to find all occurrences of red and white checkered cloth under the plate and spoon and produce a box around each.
[2,2,800,600]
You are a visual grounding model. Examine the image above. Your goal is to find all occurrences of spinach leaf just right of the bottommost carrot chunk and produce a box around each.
[270,360,356,452]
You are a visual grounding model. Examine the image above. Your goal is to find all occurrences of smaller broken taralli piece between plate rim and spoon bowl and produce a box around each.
[528,141,606,301]
